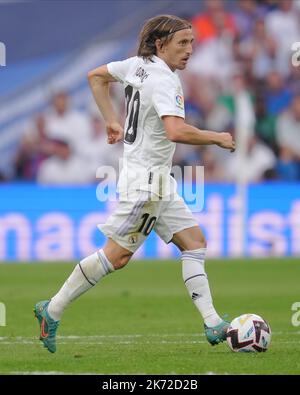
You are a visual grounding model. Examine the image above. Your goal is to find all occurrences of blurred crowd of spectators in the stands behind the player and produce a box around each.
[8,0,300,184]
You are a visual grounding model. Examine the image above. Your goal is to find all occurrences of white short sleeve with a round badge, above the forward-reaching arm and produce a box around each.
[152,78,185,118]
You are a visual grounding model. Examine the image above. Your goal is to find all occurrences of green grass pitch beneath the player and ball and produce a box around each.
[0,259,300,374]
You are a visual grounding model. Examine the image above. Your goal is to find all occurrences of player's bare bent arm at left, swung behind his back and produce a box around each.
[88,65,123,144]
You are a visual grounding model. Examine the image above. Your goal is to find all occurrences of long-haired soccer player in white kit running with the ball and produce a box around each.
[34,15,235,352]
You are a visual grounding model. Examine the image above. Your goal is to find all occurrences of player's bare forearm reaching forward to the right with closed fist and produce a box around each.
[162,115,235,151]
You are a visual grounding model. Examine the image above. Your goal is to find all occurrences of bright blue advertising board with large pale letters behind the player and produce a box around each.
[0,183,300,261]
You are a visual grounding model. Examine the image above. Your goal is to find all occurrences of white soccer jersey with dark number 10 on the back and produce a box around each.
[107,56,185,196]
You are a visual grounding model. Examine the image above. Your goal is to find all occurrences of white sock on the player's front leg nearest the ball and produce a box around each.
[182,248,223,327]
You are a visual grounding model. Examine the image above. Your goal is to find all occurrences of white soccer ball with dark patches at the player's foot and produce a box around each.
[227,314,271,352]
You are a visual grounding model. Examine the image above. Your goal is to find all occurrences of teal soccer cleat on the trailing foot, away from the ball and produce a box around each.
[33,300,59,353]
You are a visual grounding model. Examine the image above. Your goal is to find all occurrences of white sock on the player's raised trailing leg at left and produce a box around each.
[48,250,115,321]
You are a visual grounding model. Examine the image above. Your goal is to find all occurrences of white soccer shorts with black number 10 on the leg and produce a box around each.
[98,191,198,252]
